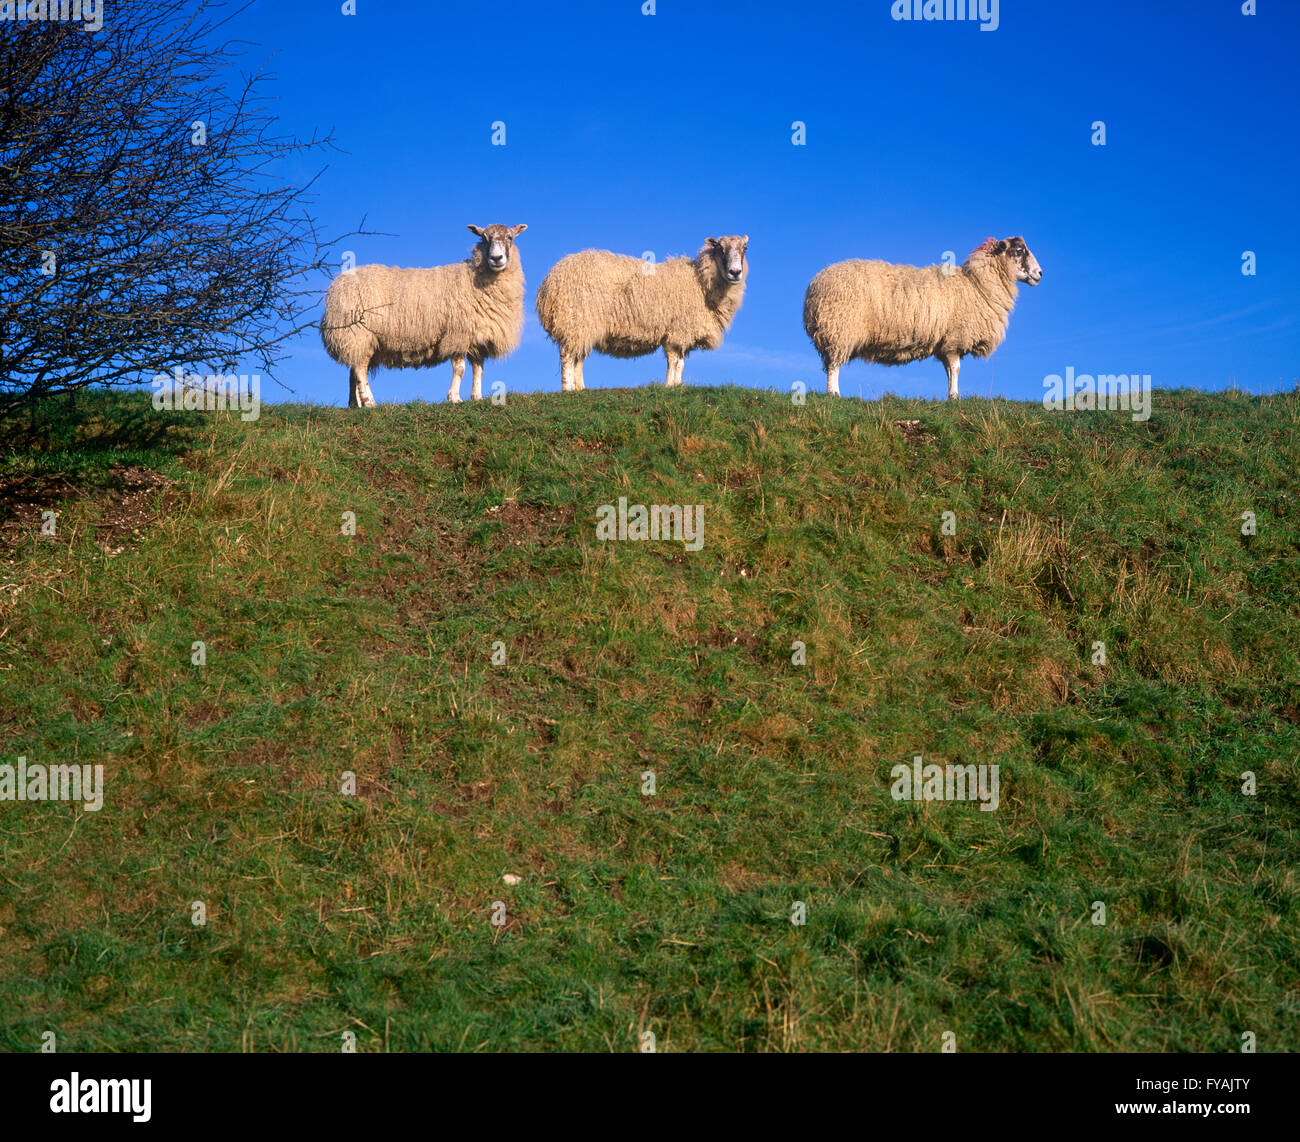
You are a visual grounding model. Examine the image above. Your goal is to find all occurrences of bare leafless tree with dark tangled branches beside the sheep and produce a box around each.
[0,0,356,416]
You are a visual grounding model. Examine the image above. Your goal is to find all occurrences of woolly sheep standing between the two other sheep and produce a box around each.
[537,235,749,393]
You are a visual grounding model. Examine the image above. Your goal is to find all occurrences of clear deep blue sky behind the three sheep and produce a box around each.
[218,0,1300,405]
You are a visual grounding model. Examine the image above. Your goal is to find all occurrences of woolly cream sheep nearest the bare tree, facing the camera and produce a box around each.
[321,225,528,408]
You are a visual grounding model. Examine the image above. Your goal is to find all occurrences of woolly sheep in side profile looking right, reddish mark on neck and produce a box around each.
[803,238,1043,401]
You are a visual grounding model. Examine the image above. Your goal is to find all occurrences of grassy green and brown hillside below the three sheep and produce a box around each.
[0,388,1300,1051]
